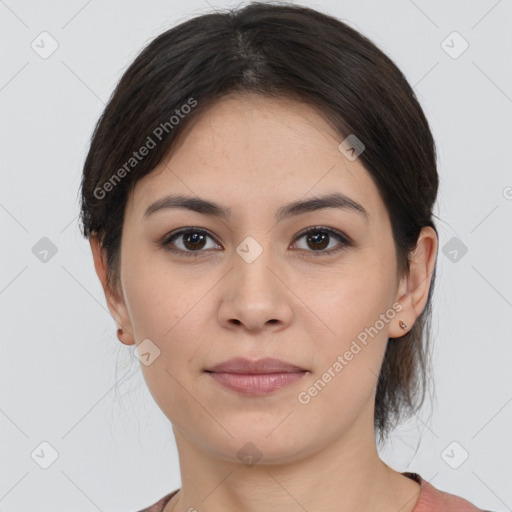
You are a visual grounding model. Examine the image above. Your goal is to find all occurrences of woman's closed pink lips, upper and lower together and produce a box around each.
[205,357,307,395]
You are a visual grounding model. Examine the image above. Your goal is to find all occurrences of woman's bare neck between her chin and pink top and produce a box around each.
[164,414,419,512]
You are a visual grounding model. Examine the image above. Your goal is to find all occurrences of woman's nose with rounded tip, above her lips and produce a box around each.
[218,243,294,332]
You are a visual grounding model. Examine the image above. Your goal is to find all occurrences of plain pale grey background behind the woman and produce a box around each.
[0,0,512,512]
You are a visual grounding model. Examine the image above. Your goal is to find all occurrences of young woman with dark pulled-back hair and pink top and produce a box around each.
[81,3,496,512]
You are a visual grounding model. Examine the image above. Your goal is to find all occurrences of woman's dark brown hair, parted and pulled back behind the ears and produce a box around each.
[80,3,438,440]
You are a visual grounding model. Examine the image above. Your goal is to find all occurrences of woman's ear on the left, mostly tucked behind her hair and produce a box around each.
[89,235,135,345]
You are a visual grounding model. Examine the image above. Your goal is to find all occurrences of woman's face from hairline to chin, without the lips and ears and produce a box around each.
[106,95,410,463]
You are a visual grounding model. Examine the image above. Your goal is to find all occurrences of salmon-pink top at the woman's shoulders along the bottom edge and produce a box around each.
[139,472,490,512]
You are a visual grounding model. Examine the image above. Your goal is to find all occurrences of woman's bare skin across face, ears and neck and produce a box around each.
[90,95,438,512]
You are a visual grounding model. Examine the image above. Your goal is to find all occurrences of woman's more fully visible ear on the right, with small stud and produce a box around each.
[389,226,438,338]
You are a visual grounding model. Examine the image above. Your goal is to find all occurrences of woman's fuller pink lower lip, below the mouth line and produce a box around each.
[206,372,306,395]
